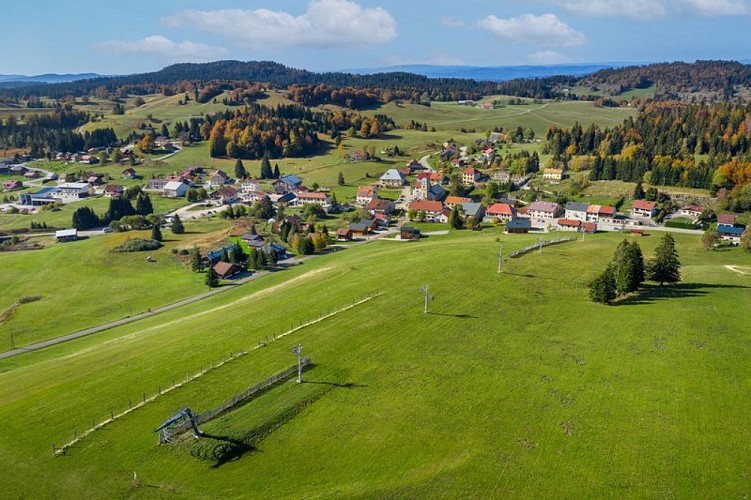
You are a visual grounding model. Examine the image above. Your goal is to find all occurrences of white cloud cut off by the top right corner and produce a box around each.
[556,0,749,20]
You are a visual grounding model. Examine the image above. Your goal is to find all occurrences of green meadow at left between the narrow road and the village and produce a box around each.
[0,221,227,351]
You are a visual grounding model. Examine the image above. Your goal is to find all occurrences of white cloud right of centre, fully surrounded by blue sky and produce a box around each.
[477,14,586,47]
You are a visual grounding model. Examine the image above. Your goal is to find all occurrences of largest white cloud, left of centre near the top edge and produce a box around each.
[163,0,396,48]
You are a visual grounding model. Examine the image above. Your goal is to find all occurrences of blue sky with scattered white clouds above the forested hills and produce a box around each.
[5,0,751,74]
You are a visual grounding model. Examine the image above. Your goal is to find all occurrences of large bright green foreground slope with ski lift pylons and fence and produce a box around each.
[0,230,751,498]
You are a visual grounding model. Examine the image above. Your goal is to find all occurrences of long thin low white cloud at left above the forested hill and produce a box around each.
[95,35,227,61]
